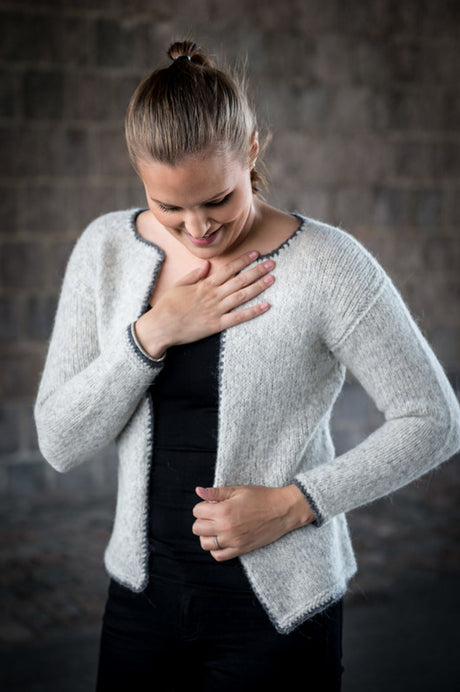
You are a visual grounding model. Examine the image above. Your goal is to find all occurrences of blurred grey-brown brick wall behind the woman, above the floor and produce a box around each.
[0,0,460,495]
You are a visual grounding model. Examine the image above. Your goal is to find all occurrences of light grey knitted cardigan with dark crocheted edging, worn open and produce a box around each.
[35,210,460,633]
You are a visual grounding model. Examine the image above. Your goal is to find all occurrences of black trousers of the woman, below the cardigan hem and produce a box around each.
[97,579,342,692]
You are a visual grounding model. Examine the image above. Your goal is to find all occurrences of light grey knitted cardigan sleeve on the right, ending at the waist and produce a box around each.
[293,238,460,526]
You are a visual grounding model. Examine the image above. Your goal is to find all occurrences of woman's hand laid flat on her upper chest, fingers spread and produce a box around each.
[135,251,275,358]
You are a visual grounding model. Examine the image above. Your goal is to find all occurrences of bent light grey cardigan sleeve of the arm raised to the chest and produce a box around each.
[34,230,163,472]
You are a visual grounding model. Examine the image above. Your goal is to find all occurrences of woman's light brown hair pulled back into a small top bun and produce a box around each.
[125,41,264,192]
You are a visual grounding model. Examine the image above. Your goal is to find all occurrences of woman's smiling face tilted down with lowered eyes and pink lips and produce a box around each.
[138,147,257,259]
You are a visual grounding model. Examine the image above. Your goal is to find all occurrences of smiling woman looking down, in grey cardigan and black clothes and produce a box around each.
[35,42,460,691]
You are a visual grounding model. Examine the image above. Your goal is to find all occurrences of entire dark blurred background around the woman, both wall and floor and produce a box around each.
[0,0,460,692]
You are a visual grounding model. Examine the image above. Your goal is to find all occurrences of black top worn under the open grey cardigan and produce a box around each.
[149,334,250,591]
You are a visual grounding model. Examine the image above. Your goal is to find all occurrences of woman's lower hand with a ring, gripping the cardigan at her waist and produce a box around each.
[192,485,315,562]
